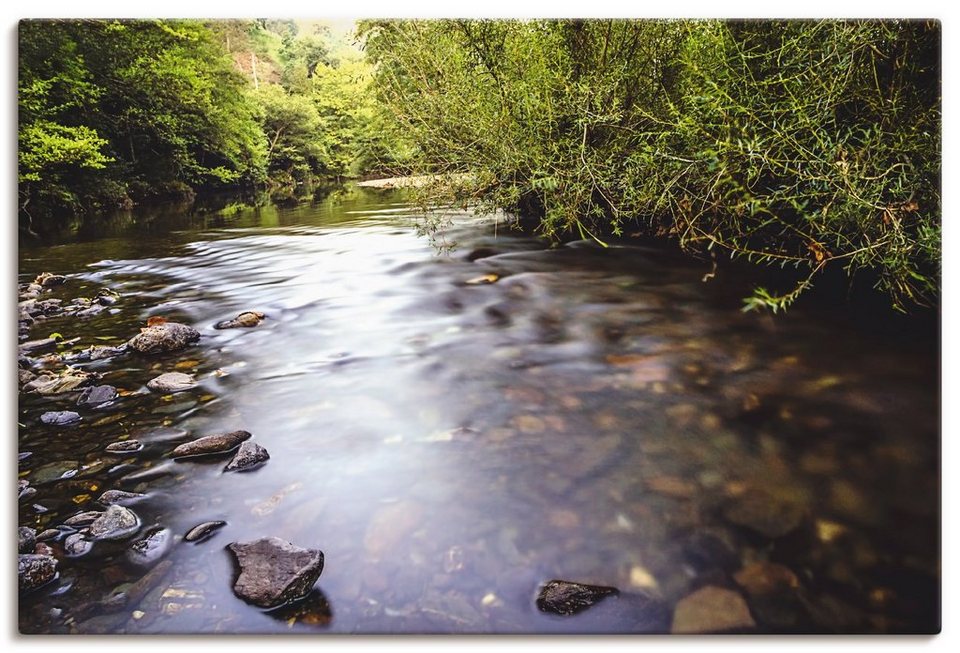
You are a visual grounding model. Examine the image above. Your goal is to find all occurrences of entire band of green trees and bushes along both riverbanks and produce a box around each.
[19,19,941,310]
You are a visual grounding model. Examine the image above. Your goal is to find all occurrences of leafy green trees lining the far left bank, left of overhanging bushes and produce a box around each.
[19,20,402,229]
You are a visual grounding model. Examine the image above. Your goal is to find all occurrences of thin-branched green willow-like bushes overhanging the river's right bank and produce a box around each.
[363,20,940,310]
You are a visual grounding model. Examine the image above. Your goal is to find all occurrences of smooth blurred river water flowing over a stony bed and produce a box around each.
[18,183,940,633]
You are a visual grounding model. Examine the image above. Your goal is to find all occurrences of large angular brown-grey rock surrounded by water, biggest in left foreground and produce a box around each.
[228,537,323,608]
